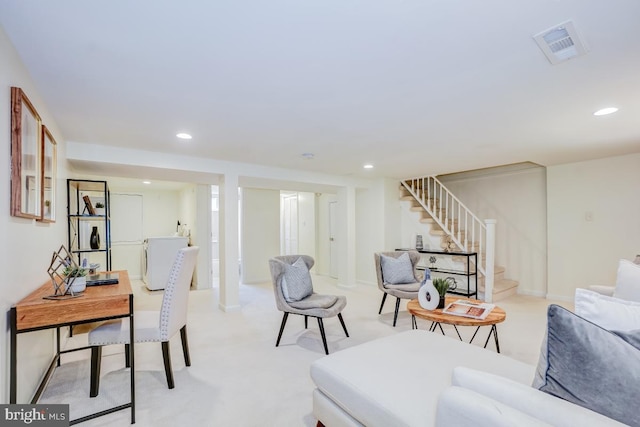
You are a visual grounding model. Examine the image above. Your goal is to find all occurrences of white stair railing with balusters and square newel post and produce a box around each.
[402,176,496,302]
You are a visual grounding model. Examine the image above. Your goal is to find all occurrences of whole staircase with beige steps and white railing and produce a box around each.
[400,176,518,302]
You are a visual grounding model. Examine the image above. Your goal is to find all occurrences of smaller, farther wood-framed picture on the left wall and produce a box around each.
[40,125,58,222]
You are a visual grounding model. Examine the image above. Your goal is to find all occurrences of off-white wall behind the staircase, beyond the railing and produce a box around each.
[442,167,547,296]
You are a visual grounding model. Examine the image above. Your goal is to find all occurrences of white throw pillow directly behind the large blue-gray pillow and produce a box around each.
[575,288,640,331]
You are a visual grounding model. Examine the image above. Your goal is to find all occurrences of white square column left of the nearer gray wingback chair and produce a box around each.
[218,173,240,311]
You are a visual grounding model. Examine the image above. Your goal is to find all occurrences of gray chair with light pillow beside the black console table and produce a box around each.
[373,251,421,327]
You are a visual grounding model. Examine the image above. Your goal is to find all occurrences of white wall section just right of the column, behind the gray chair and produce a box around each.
[241,188,280,283]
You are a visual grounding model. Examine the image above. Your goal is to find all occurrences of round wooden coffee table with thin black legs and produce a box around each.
[407,297,507,353]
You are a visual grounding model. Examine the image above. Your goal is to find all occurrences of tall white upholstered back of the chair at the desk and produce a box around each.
[160,246,200,341]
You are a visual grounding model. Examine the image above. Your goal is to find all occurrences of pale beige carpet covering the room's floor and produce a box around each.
[40,277,571,427]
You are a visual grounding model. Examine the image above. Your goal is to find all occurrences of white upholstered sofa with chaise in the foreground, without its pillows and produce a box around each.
[311,330,624,427]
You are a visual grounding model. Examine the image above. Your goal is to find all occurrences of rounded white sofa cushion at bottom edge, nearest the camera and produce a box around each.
[435,387,552,427]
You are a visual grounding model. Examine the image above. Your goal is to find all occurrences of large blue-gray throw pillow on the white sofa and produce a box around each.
[539,305,640,426]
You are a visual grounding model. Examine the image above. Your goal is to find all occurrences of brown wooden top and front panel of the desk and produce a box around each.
[14,270,133,332]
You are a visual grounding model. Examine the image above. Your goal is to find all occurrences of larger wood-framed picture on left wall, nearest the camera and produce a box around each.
[11,87,42,219]
